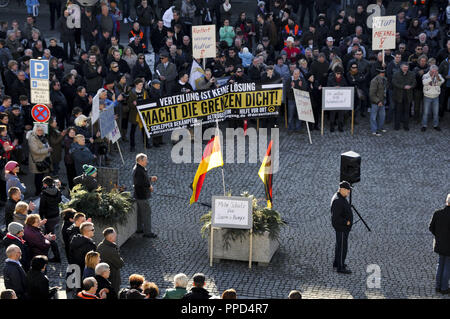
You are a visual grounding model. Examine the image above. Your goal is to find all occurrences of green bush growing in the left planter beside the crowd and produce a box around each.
[62,184,133,224]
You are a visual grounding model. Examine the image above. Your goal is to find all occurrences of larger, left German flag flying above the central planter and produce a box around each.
[189,135,223,204]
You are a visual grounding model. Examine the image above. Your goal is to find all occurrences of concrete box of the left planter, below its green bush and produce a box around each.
[92,203,137,247]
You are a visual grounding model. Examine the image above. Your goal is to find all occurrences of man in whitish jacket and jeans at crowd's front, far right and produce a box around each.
[422,65,445,132]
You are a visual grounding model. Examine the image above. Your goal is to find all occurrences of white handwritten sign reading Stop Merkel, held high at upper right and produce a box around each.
[372,16,396,50]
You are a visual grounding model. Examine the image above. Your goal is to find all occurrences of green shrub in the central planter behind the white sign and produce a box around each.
[200,192,285,249]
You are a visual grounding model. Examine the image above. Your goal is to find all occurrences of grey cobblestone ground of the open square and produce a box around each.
[0,1,450,298]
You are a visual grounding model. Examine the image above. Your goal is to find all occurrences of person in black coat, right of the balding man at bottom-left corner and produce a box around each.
[27,255,58,300]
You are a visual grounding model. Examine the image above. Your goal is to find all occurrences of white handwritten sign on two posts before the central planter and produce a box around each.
[211,196,253,229]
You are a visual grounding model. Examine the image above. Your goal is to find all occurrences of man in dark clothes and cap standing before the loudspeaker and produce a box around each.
[331,181,353,274]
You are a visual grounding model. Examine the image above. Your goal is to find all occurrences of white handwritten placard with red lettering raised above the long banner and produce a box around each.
[192,24,216,59]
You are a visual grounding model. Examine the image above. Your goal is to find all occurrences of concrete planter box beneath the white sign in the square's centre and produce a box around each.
[208,228,280,266]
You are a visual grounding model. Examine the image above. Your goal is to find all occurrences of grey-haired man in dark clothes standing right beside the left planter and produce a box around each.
[133,153,158,238]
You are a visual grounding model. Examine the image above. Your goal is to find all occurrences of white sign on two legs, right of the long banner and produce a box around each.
[322,86,355,111]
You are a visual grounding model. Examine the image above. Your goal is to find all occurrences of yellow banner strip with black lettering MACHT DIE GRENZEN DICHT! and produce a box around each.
[140,89,282,130]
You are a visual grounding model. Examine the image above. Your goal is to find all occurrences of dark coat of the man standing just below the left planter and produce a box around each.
[97,239,124,293]
